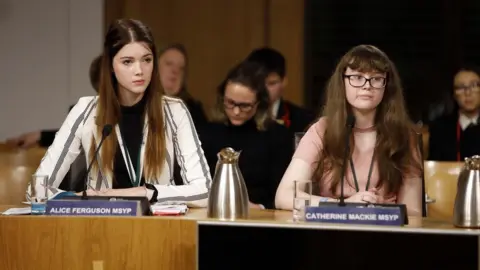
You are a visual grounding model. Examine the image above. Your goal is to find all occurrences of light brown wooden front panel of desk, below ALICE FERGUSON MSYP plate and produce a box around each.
[0,207,197,270]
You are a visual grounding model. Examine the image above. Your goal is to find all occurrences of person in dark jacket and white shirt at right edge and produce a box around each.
[428,67,480,161]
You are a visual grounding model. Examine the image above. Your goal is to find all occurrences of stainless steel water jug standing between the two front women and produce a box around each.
[207,147,249,220]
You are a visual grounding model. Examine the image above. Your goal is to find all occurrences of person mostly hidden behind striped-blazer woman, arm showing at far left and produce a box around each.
[7,55,102,149]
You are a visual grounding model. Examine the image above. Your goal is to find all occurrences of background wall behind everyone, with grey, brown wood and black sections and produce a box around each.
[0,0,480,140]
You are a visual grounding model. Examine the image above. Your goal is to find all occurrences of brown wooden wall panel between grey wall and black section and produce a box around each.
[104,0,304,115]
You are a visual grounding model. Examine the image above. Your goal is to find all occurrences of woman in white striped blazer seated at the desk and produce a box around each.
[27,19,211,207]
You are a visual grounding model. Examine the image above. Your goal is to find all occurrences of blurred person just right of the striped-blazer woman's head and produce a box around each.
[159,43,207,126]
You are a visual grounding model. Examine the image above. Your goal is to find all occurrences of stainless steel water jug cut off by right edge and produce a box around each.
[453,156,480,228]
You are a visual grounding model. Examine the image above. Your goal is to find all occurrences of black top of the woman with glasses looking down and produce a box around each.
[198,120,294,209]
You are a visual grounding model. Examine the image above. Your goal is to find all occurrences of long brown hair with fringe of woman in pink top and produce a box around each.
[316,45,421,194]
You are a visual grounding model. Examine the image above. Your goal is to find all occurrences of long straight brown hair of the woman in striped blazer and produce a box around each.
[89,19,165,180]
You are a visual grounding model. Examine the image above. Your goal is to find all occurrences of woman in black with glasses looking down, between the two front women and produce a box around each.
[199,62,293,208]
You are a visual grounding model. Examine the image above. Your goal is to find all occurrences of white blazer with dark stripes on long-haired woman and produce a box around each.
[27,96,211,207]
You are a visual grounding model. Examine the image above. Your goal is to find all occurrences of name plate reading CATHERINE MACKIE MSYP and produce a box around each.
[305,204,405,226]
